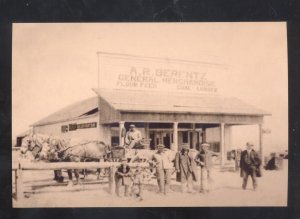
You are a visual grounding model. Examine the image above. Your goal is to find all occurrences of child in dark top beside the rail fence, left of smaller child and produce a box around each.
[115,158,132,197]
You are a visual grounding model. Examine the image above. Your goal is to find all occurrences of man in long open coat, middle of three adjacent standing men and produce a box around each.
[175,144,198,193]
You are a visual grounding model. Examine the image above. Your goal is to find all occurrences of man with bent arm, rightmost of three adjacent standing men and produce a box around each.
[195,143,218,193]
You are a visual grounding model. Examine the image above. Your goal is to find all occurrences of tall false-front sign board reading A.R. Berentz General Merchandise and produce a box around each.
[98,53,225,93]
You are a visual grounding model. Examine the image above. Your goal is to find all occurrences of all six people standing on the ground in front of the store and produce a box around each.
[116,139,261,200]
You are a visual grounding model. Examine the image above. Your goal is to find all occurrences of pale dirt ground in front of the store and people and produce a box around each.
[13,157,288,207]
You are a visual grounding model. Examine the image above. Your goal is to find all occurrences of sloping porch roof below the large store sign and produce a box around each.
[93,89,271,116]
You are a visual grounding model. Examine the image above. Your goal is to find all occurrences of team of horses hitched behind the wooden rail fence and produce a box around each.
[20,134,109,182]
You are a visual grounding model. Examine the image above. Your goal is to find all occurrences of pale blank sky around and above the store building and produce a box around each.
[12,22,288,151]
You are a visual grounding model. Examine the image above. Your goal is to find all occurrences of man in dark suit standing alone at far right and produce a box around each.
[240,142,261,190]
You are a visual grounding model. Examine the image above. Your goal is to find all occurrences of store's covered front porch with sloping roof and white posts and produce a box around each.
[95,90,268,164]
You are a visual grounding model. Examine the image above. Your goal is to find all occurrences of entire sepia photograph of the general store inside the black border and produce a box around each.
[11,22,288,208]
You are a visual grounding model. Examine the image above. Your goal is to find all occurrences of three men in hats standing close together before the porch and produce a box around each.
[153,143,215,194]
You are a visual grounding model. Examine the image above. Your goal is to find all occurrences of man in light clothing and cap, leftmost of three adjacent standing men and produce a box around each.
[152,144,173,195]
